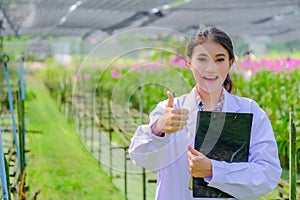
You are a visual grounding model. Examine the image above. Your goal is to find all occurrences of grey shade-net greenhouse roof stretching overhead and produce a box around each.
[0,0,300,41]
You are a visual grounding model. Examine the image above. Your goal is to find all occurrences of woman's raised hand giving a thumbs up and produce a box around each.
[156,91,189,134]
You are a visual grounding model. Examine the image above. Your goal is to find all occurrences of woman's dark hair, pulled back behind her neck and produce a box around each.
[187,26,235,92]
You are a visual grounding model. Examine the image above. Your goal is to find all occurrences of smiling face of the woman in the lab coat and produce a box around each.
[188,40,234,93]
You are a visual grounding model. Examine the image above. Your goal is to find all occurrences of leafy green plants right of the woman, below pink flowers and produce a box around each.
[234,68,300,169]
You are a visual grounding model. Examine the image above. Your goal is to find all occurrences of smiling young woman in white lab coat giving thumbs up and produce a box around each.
[129,27,281,200]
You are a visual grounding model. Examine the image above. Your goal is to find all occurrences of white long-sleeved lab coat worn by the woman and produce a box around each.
[129,88,281,200]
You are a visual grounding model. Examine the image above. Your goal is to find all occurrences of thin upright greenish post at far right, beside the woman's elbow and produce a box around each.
[289,112,297,200]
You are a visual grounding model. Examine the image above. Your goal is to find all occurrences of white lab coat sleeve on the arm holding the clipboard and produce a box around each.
[205,103,282,200]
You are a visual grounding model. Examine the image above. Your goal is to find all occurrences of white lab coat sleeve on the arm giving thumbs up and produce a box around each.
[129,101,171,171]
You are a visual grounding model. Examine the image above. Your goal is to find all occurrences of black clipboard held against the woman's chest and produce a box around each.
[193,111,253,198]
